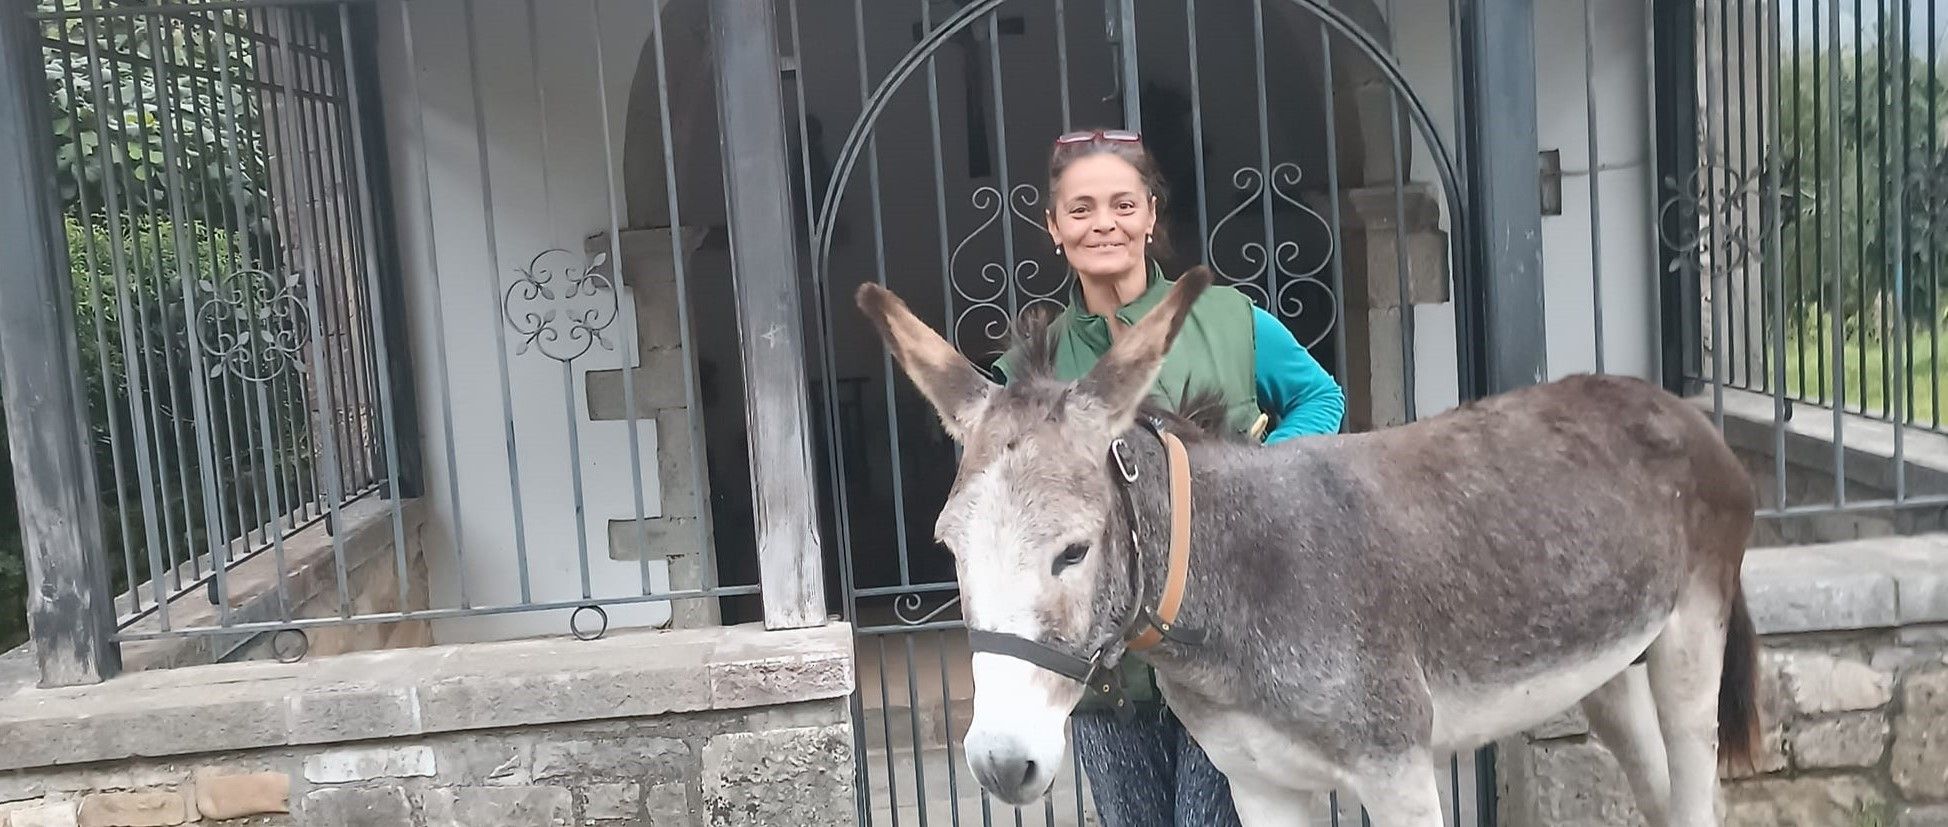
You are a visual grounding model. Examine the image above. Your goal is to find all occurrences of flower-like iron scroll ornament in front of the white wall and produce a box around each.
[501,247,618,362]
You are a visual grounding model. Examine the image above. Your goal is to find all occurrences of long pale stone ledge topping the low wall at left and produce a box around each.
[0,623,853,771]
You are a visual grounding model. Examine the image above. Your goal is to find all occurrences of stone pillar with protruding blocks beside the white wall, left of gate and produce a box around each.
[586,228,723,629]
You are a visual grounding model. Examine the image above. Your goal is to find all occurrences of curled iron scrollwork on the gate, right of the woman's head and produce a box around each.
[1204,162,1338,346]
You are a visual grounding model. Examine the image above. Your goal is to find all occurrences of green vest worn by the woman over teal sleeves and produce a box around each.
[995,261,1260,710]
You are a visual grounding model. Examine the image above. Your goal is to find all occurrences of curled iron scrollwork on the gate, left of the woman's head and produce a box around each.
[947,183,1071,350]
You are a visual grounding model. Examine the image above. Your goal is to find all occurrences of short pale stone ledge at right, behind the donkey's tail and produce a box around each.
[1743,533,1948,634]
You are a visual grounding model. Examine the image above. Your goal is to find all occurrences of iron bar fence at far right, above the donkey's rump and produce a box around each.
[1654,0,1948,521]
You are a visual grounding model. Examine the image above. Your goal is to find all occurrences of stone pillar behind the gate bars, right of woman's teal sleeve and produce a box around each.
[1340,183,1449,430]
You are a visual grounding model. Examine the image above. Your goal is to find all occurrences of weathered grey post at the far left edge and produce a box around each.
[0,2,121,687]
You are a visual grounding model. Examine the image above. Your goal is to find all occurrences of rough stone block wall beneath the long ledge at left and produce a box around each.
[0,701,853,827]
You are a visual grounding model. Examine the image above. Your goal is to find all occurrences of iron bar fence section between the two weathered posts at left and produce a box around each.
[18,0,758,658]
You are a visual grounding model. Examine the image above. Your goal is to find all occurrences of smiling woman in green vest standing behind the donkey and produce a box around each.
[995,130,1346,827]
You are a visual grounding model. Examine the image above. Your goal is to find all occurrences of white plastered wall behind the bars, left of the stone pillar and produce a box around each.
[368,0,668,642]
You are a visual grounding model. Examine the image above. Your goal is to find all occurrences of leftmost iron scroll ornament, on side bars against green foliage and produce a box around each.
[197,269,310,381]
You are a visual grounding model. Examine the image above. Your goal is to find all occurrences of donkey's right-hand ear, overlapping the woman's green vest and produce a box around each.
[1075,267,1212,434]
